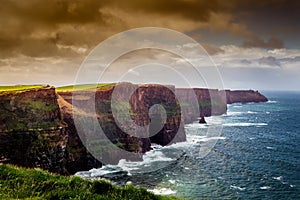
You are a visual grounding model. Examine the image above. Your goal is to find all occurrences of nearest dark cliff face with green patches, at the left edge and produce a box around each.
[0,87,66,174]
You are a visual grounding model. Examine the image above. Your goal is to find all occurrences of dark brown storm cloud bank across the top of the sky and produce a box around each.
[0,0,300,58]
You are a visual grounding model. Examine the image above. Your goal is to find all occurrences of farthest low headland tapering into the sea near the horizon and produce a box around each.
[225,90,268,104]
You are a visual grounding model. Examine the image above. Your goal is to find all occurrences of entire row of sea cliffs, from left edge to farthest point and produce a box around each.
[0,83,267,174]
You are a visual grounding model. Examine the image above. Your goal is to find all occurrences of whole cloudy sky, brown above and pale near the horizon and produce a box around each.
[0,0,300,90]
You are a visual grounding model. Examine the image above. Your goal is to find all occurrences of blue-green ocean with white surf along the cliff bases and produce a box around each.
[77,91,300,199]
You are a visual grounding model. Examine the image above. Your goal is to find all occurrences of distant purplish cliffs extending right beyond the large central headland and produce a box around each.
[176,88,268,123]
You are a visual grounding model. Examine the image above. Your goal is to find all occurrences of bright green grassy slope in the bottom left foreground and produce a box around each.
[0,164,180,200]
